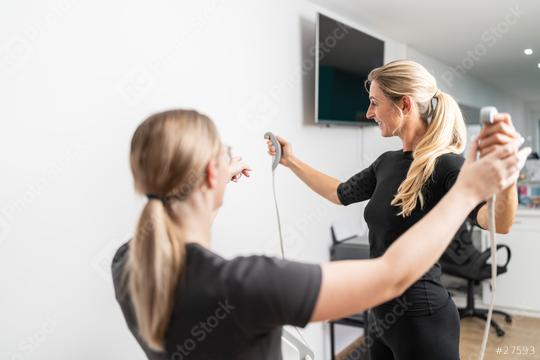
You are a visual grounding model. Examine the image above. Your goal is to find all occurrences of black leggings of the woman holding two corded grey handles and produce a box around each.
[365,298,460,360]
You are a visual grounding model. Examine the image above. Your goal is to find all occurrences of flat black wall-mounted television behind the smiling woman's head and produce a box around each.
[315,13,384,125]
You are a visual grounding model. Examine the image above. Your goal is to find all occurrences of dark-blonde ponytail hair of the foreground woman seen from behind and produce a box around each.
[124,110,221,351]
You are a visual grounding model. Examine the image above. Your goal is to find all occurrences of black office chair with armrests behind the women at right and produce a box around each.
[440,220,512,337]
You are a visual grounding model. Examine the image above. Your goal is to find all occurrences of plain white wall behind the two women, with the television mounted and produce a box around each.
[0,0,532,359]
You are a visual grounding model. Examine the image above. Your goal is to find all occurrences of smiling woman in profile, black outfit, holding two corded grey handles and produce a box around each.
[268,60,520,360]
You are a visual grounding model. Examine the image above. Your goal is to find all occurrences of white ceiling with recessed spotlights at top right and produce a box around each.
[312,0,540,108]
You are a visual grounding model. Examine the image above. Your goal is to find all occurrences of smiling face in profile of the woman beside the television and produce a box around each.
[366,80,401,137]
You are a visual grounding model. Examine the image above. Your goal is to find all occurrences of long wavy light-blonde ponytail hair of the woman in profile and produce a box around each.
[367,60,467,217]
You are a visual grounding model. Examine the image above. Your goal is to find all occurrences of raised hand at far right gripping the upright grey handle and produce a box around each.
[478,113,521,157]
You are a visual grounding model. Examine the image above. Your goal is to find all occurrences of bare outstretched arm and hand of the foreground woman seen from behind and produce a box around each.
[310,142,530,322]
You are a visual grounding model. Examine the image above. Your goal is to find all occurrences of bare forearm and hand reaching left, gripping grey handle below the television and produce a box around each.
[267,136,341,205]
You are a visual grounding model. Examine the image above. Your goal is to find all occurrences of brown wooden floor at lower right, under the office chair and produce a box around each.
[336,315,540,360]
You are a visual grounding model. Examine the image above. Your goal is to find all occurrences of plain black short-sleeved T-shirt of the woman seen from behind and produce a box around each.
[112,242,321,360]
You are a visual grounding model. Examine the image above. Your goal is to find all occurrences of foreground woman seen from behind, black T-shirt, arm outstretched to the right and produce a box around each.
[112,110,530,360]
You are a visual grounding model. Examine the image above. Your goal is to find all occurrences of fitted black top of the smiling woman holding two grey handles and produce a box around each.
[337,150,481,315]
